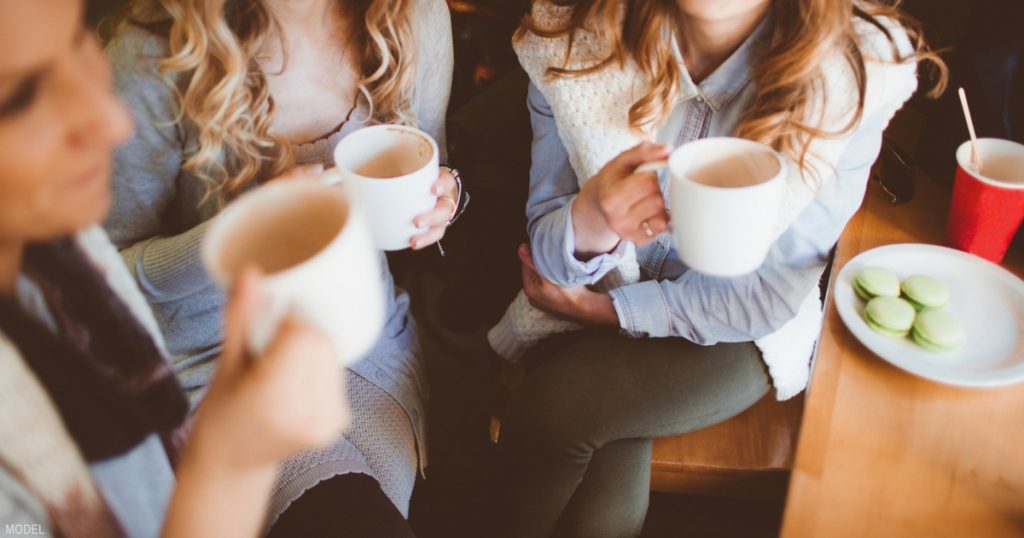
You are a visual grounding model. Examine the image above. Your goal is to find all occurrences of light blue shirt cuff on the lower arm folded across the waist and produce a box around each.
[608,280,672,338]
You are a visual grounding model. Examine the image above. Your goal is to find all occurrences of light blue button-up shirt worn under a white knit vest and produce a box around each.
[526,19,890,345]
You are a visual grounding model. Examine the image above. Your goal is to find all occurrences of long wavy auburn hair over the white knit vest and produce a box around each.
[514,0,947,180]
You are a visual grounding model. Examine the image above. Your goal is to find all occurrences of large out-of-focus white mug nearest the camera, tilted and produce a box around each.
[203,180,385,364]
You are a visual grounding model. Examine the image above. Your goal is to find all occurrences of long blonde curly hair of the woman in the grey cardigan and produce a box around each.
[124,0,416,198]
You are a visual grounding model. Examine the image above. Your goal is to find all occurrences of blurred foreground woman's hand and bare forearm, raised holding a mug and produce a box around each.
[163,270,348,538]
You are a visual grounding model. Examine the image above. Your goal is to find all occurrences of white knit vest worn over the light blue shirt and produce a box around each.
[507,1,918,400]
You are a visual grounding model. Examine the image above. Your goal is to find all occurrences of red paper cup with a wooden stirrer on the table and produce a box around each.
[946,138,1024,263]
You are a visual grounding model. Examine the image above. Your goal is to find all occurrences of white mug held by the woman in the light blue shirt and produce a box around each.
[637,137,787,277]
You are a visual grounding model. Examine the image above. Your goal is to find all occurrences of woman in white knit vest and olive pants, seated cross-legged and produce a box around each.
[489,0,944,537]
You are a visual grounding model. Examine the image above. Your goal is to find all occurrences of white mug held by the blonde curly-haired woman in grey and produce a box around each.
[324,125,439,250]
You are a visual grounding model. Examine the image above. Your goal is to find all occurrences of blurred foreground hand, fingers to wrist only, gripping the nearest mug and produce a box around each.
[185,270,348,466]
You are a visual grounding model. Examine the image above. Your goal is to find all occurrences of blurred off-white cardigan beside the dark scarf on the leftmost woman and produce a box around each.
[0,226,166,536]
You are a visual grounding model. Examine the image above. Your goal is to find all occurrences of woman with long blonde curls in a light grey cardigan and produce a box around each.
[106,0,459,536]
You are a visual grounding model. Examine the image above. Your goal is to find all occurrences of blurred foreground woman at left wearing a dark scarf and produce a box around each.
[0,0,344,537]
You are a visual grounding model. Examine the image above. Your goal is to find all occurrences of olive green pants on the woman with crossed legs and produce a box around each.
[494,331,771,538]
